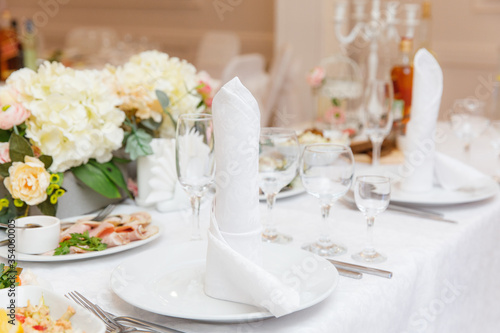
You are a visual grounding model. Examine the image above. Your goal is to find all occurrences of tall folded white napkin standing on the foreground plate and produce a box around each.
[205,77,300,317]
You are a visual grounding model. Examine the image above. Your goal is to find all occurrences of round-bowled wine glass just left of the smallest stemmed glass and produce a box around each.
[299,143,354,256]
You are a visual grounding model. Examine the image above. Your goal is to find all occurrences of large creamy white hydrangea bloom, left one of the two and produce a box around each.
[7,62,125,172]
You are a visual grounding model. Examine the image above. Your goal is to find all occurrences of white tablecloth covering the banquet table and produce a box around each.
[2,124,500,333]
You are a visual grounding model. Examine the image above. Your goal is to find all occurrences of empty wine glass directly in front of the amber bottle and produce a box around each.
[363,79,394,166]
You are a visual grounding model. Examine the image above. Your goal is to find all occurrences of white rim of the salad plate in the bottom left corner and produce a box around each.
[0,286,106,333]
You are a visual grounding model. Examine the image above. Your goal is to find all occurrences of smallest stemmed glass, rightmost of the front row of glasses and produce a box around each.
[352,176,391,262]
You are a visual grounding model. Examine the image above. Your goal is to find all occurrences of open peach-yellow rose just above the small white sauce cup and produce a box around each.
[4,156,50,206]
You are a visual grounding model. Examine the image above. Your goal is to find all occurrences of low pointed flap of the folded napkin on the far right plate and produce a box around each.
[434,152,490,191]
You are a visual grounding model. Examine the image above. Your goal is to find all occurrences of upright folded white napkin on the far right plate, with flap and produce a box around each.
[401,49,489,192]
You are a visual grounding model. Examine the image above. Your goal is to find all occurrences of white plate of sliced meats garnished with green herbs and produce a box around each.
[0,211,161,262]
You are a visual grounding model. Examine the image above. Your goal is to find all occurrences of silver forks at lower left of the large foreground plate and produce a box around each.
[64,291,183,333]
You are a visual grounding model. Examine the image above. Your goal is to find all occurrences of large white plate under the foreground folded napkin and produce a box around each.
[111,241,339,323]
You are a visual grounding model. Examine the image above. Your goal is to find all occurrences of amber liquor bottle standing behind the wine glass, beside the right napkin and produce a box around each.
[391,38,413,134]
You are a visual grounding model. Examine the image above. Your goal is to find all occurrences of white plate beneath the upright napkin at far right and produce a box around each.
[391,179,499,206]
